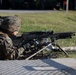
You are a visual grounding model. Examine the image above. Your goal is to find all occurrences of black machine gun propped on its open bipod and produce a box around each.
[16,31,75,59]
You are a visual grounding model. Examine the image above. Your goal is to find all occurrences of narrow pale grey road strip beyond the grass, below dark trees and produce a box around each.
[0,10,60,13]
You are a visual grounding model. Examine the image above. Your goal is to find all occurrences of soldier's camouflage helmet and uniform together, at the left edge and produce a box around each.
[0,16,21,60]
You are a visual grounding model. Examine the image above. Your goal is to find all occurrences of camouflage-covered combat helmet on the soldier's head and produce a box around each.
[0,16,21,32]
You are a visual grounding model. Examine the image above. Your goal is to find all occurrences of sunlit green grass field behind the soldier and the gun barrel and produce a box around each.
[0,11,76,46]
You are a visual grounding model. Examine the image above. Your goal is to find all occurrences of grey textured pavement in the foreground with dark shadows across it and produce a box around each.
[0,58,76,75]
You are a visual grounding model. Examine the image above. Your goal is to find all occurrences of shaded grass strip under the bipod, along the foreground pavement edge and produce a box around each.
[44,51,76,58]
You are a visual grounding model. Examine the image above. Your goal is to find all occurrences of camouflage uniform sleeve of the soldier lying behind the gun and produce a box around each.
[0,36,17,60]
